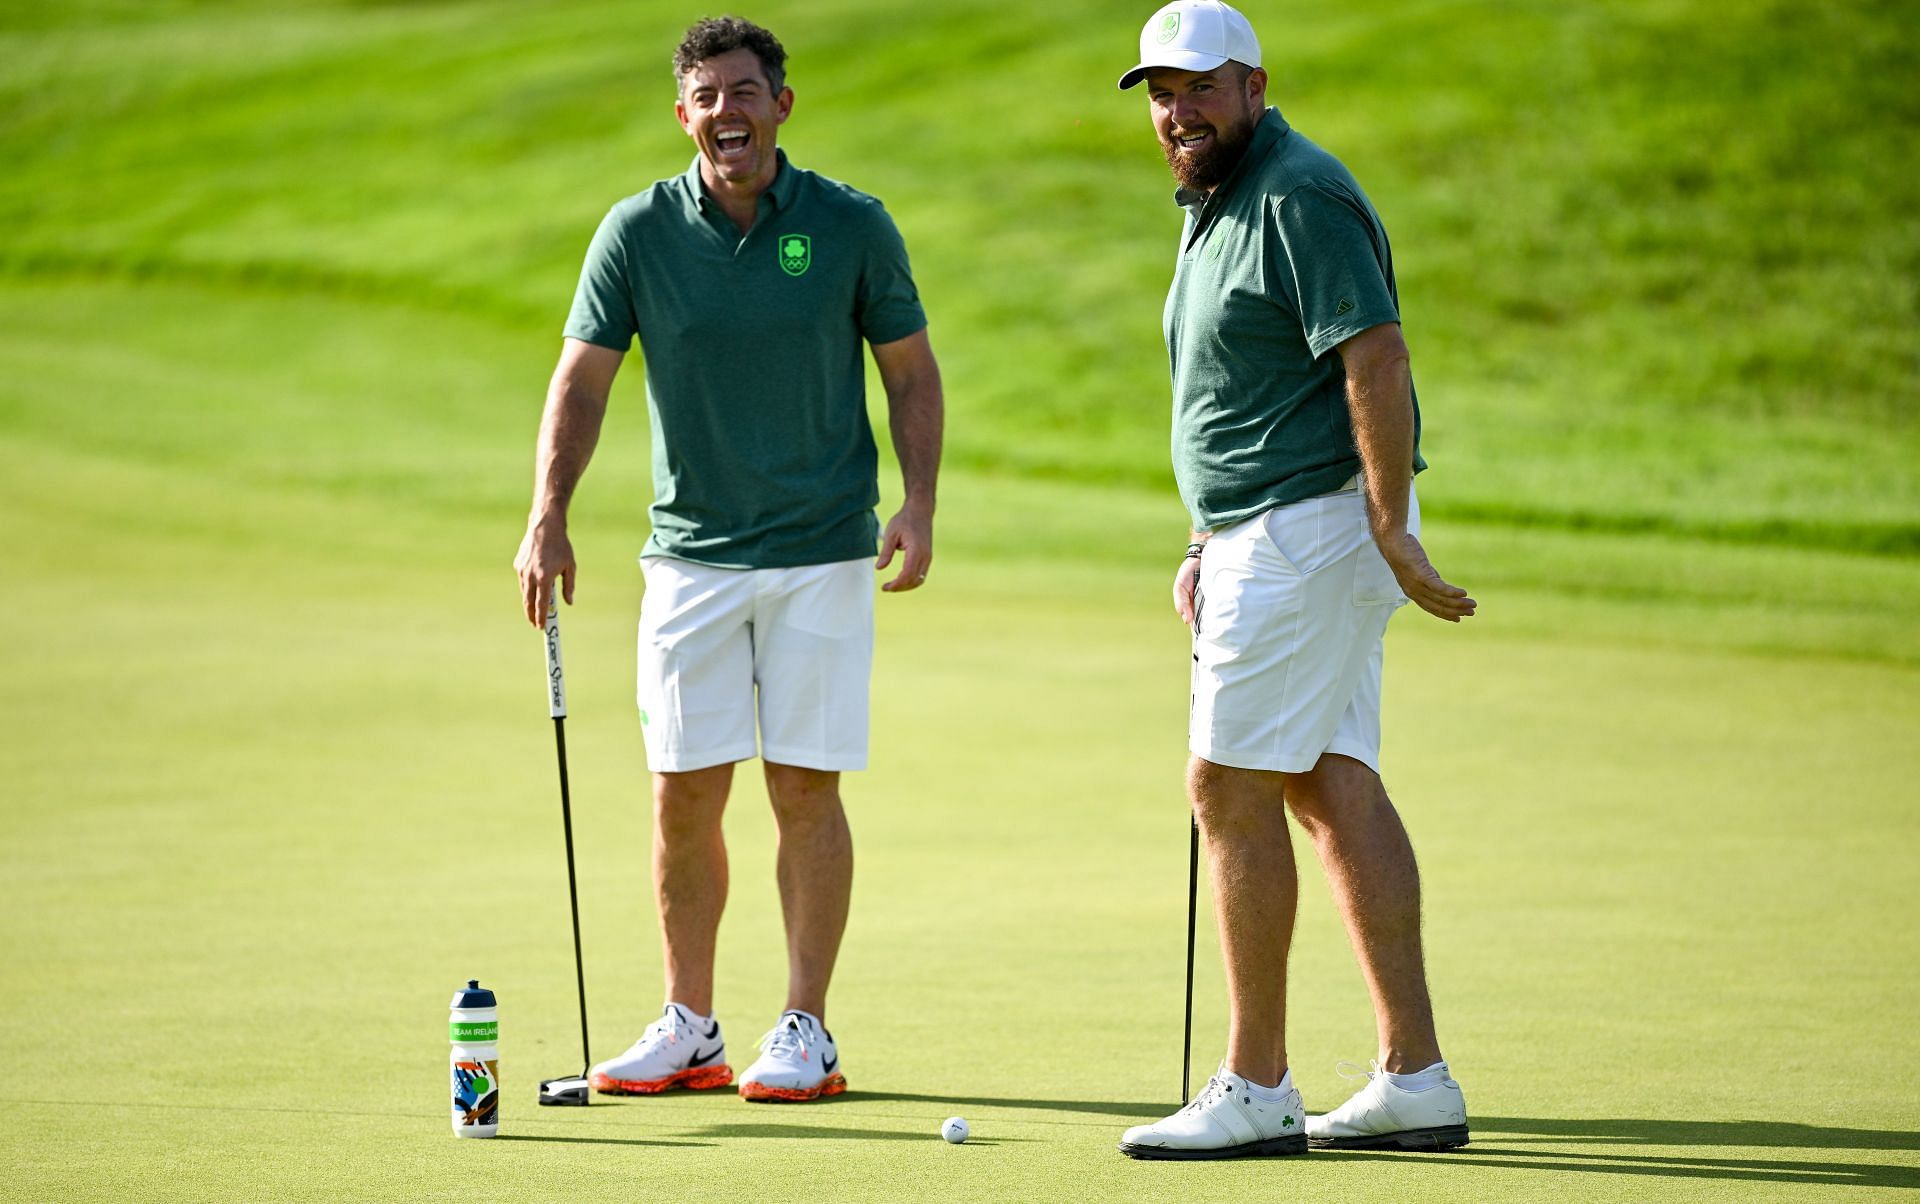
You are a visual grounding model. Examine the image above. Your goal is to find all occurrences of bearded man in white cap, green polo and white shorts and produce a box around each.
[1119,0,1475,1158]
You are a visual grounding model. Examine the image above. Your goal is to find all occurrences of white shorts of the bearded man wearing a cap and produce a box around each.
[1187,488,1421,774]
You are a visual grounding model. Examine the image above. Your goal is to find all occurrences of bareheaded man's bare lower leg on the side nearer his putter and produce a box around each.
[653,764,733,1016]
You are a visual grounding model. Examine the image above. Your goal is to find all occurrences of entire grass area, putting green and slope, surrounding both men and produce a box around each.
[0,2,1920,1198]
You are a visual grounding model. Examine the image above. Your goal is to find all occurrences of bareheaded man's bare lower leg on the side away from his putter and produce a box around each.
[766,762,852,1023]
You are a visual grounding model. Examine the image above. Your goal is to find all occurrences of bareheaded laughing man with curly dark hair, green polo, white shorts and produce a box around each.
[515,17,941,1100]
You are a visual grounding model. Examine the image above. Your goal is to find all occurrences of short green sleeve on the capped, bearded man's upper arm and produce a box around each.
[1273,184,1400,357]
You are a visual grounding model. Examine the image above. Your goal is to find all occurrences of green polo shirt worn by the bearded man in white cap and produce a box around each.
[1165,109,1427,530]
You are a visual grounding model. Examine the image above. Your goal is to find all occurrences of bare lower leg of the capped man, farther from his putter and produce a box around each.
[1286,753,1440,1073]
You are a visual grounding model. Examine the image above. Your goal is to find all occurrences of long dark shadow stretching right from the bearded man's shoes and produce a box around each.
[1313,1116,1920,1189]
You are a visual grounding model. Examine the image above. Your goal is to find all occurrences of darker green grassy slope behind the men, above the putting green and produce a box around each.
[0,0,1920,551]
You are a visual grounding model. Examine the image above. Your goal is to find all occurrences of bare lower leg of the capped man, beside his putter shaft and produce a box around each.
[1187,757,1300,1087]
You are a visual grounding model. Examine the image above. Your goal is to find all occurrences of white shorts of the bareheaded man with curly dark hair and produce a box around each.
[637,557,874,774]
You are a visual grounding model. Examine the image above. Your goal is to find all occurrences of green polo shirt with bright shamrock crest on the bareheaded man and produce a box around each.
[566,152,927,568]
